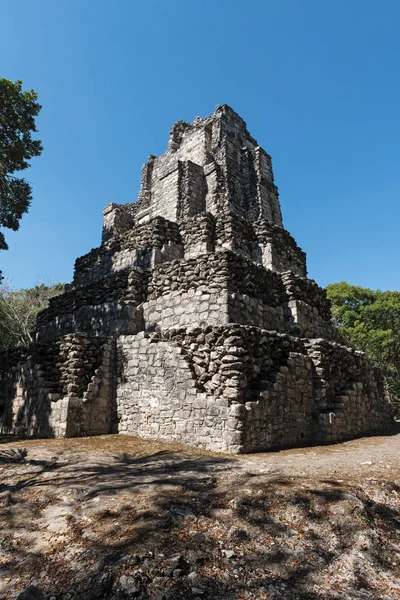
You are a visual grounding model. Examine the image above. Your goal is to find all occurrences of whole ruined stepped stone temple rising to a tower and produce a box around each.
[0,105,393,453]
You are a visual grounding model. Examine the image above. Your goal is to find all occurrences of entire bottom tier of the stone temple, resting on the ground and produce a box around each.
[0,324,392,453]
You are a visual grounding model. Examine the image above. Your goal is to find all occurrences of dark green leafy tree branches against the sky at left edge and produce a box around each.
[0,78,42,276]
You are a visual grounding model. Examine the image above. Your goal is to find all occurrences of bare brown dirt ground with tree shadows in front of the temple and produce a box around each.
[0,432,400,600]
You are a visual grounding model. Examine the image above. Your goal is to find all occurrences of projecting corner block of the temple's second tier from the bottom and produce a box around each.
[143,251,289,331]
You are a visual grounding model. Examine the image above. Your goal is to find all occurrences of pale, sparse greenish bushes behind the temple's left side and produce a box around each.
[0,283,64,351]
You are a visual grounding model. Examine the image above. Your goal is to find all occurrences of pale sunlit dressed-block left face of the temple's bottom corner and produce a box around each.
[117,334,235,450]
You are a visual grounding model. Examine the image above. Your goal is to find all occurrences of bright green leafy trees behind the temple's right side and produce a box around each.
[327,281,400,414]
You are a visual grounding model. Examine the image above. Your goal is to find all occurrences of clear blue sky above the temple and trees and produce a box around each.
[0,0,400,289]
